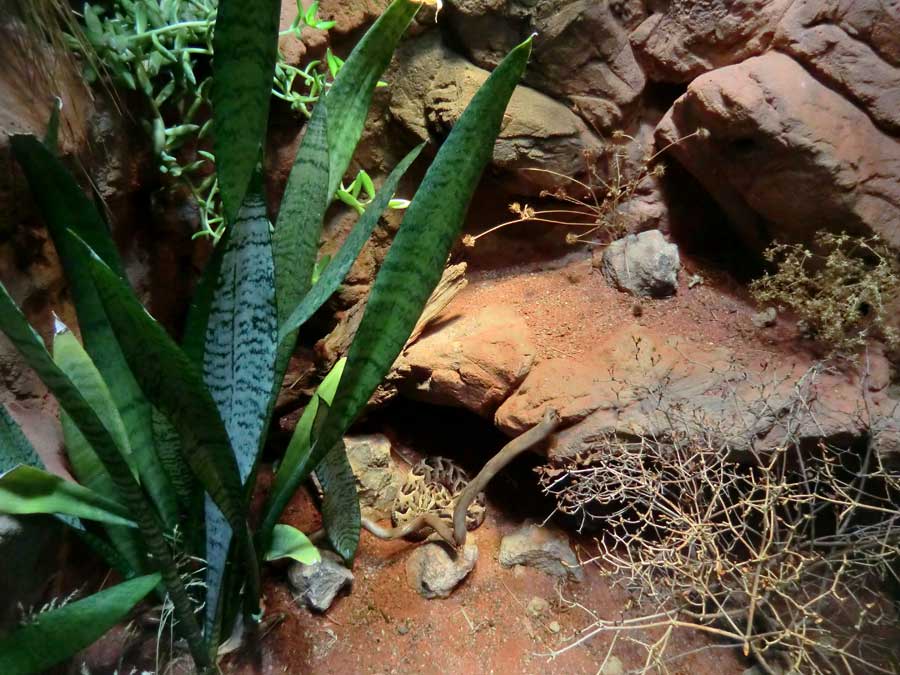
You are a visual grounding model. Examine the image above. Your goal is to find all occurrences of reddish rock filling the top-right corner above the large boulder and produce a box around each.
[775,0,900,133]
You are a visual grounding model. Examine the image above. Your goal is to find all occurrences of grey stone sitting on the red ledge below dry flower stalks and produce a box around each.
[600,230,681,298]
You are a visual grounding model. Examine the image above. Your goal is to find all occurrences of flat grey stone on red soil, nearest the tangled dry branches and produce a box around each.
[500,523,584,581]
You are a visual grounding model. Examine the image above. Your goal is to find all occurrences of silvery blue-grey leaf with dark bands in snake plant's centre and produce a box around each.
[203,180,277,630]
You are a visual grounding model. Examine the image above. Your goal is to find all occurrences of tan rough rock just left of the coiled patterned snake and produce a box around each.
[344,434,402,520]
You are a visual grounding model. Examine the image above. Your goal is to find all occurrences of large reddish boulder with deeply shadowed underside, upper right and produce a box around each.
[657,52,900,252]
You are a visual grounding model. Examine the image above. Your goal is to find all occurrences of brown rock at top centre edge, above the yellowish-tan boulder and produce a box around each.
[446,0,644,131]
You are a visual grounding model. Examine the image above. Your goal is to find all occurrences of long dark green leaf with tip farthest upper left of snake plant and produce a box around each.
[10,136,178,528]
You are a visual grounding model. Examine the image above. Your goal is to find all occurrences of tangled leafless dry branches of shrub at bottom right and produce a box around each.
[541,371,900,674]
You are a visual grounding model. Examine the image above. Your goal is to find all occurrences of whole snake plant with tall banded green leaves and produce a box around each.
[0,0,530,673]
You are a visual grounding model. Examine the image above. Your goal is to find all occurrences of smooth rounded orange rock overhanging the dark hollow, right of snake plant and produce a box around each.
[394,307,535,417]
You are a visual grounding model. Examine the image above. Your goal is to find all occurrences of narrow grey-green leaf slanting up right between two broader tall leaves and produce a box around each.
[279,145,424,340]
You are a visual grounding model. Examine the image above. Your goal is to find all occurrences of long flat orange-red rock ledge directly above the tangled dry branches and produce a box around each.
[495,324,900,459]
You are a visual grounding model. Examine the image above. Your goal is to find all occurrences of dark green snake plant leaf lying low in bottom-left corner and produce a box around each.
[0,574,160,675]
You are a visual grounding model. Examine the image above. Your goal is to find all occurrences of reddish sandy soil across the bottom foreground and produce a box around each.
[229,496,747,675]
